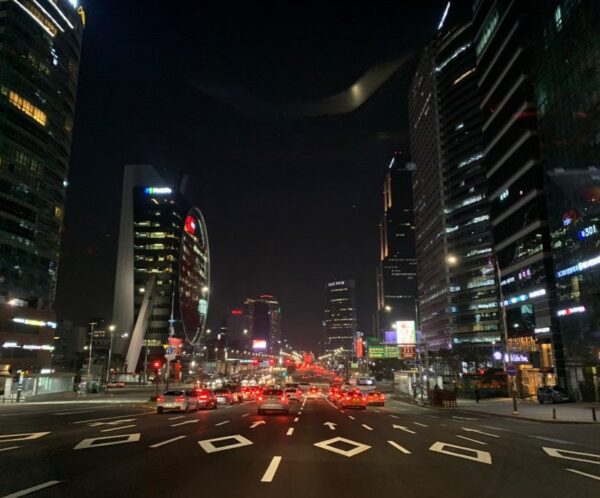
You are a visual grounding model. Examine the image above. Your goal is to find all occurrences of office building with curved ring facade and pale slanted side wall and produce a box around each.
[113,165,210,372]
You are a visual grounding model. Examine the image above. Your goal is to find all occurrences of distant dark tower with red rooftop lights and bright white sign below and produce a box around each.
[244,294,281,353]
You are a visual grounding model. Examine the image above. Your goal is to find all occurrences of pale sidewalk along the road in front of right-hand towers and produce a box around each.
[457,398,600,423]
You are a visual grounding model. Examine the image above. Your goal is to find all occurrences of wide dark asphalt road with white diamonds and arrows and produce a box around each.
[0,399,600,498]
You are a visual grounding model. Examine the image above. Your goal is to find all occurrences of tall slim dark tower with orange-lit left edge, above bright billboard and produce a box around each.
[377,152,417,335]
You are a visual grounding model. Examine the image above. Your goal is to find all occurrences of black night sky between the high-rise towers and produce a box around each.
[57,0,445,349]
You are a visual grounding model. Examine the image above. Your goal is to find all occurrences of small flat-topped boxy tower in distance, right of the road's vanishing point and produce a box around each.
[323,280,357,352]
